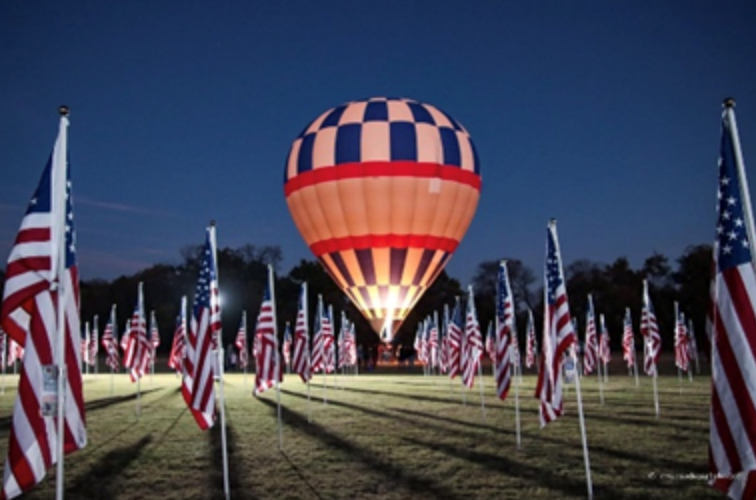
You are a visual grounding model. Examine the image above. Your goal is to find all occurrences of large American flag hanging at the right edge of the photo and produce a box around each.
[709,100,756,499]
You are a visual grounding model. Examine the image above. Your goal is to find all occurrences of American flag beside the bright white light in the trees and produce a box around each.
[181,224,221,430]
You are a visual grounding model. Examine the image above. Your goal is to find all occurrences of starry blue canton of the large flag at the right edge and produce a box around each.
[716,117,751,271]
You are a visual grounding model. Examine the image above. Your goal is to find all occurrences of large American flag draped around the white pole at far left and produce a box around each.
[0,115,87,498]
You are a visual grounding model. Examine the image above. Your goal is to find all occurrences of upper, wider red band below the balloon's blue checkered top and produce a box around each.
[284,161,481,196]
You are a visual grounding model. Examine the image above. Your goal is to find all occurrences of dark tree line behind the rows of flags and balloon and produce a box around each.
[0,245,712,354]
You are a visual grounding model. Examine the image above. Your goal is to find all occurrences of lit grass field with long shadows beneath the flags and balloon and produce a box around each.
[0,373,722,500]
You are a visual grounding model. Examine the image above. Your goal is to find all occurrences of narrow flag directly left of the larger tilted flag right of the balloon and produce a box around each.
[494,260,514,400]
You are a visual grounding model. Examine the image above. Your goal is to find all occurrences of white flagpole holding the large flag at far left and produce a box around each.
[53,106,70,500]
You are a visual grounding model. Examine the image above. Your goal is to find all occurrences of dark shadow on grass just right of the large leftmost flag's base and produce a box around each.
[66,436,152,500]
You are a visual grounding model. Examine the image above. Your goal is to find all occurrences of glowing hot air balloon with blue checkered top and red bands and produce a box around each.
[284,97,481,340]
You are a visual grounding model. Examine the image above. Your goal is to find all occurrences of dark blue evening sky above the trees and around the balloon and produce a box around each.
[0,0,756,283]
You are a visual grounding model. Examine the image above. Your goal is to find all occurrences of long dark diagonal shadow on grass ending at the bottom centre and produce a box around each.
[258,391,461,500]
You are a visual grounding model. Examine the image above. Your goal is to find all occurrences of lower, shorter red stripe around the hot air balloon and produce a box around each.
[310,234,459,257]
